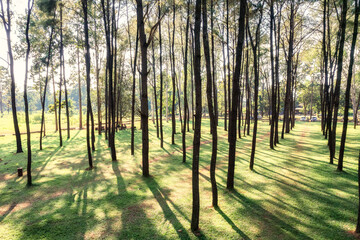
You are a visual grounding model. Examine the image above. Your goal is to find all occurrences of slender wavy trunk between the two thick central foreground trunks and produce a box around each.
[202,0,218,207]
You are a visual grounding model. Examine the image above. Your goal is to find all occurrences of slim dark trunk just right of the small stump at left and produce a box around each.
[24,0,34,186]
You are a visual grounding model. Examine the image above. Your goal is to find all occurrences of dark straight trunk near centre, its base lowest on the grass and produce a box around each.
[191,0,202,231]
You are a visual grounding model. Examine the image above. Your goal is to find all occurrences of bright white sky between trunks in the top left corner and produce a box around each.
[0,0,27,91]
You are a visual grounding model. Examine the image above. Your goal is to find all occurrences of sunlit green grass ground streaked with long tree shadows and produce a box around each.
[0,119,360,240]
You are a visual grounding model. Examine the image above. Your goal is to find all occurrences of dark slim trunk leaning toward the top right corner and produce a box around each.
[337,0,360,171]
